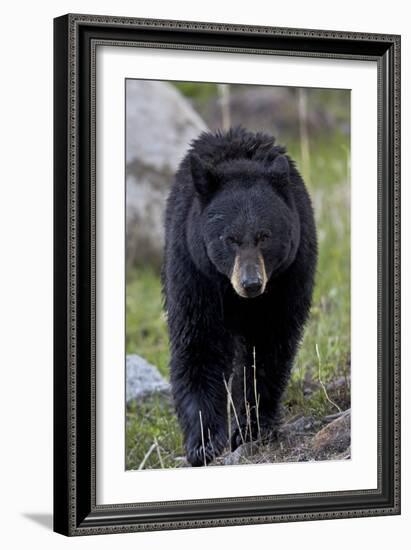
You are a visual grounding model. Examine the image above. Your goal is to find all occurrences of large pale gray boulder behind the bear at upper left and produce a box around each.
[126,80,206,267]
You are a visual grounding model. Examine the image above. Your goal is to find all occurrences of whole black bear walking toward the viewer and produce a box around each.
[162,127,317,466]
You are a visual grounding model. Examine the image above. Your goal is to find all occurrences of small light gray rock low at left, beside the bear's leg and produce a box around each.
[126,355,170,403]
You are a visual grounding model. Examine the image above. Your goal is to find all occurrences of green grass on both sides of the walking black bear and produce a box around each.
[126,134,350,469]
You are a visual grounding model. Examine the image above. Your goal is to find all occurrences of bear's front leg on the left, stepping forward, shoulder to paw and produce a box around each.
[165,252,234,466]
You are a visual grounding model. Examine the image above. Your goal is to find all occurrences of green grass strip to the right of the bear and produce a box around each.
[286,135,350,416]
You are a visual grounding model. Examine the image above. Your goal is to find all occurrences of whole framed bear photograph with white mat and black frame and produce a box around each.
[54,14,400,536]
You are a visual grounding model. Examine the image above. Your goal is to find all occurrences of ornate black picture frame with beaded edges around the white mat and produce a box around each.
[54,14,400,536]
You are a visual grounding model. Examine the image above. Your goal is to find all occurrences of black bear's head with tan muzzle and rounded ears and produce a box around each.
[190,153,300,298]
